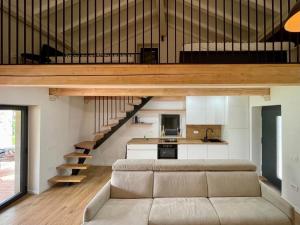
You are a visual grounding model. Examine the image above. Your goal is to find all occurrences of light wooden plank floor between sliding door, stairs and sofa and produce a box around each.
[0,166,111,225]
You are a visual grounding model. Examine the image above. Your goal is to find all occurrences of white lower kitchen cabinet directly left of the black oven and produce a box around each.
[126,144,157,159]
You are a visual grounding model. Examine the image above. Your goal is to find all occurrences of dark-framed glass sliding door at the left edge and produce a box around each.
[0,105,28,209]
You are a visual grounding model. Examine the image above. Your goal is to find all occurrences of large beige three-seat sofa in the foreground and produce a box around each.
[84,160,294,225]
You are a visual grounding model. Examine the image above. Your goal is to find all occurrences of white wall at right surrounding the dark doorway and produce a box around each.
[250,87,300,212]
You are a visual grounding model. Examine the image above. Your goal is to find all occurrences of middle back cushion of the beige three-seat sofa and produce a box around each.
[153,172,207,198]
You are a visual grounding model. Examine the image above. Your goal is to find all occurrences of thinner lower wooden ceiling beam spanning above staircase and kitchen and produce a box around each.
[49,88,270,97]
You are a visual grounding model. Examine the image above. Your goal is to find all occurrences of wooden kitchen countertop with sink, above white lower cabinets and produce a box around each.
[127,138,228,145]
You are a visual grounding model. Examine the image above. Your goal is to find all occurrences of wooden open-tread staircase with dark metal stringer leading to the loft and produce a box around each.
[49,97,151,184]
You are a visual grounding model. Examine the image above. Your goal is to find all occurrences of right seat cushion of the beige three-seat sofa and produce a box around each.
[210,197,291,225]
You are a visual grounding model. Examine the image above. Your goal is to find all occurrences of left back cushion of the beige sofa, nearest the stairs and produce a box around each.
[110,171,153,199]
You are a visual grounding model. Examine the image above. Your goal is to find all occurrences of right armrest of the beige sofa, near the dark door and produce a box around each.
[260,181,294,221]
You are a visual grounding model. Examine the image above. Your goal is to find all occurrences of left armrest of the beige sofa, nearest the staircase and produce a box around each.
[83,180,110,223]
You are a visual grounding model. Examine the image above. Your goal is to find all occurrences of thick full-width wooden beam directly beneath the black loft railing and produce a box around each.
[0,64,300,87]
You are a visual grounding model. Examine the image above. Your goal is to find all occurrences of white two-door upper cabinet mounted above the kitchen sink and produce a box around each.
[186,96,225,125]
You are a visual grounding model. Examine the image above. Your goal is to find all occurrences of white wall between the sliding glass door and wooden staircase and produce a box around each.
[0,87,83,193]
